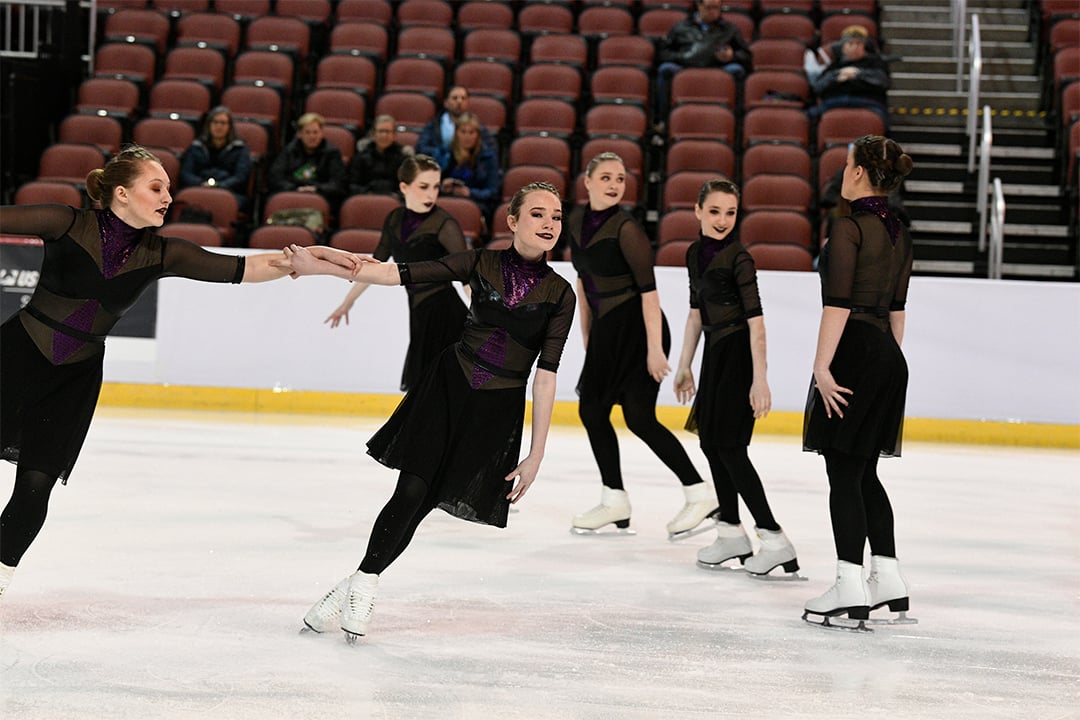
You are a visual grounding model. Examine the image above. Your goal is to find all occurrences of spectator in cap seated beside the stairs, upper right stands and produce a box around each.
[809,25,891,130]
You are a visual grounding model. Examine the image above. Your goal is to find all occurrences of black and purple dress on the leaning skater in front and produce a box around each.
[367,247,575,528]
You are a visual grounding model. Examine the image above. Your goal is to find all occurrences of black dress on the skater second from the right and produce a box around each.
[686,233,762,448]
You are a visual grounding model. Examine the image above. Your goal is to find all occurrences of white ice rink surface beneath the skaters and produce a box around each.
[0,409,1080,720]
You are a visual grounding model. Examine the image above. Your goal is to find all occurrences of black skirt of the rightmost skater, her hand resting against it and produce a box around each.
[802,320,907,459]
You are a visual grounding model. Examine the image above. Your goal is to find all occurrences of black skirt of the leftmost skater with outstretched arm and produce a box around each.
[0,314,104,481]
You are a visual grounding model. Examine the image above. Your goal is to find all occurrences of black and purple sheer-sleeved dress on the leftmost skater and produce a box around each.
[0,205,244,481]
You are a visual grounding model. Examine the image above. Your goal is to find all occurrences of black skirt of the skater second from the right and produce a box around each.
[686,328,754,448]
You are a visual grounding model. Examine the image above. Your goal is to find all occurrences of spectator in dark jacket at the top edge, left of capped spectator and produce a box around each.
[652,0,752,126]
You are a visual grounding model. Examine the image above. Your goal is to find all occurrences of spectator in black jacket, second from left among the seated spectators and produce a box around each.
[267,112,347,206]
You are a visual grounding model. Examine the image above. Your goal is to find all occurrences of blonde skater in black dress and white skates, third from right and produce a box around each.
[565,152,716,540]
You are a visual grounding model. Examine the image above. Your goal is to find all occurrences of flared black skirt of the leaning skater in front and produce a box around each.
[367,347,525,528]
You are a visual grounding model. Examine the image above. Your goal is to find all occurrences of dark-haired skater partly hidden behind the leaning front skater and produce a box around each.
[325,155,465,392]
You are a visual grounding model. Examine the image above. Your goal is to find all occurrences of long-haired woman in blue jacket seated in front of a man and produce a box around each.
[434,112,502,227]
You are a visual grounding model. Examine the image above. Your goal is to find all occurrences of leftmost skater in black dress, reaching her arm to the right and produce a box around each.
[0,146,355,596]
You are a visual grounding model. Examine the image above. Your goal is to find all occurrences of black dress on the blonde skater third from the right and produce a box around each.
[566,205,671,405]
